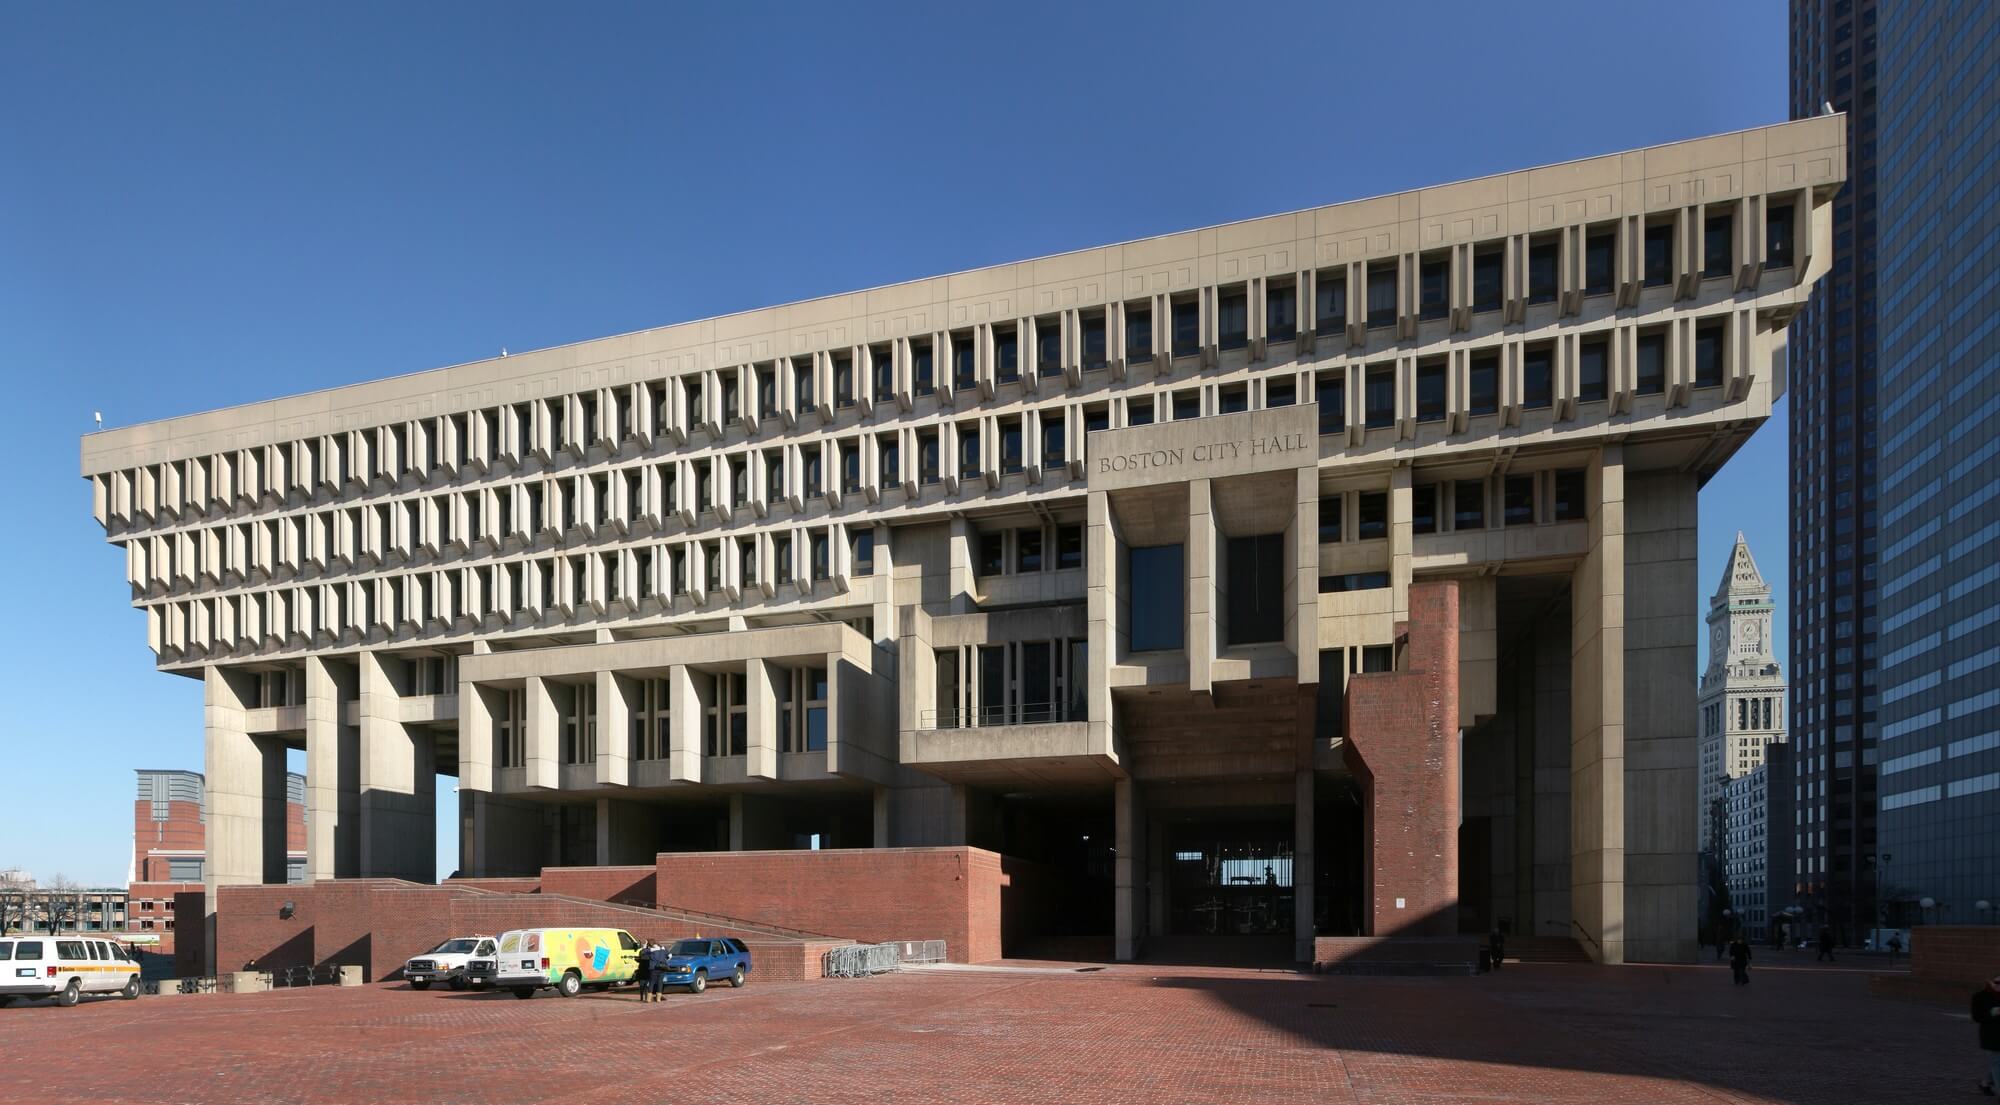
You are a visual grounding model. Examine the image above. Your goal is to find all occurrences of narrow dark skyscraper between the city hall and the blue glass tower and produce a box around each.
[1770,0,1890,941]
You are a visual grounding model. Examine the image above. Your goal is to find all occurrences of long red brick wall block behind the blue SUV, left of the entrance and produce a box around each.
[658,847,1016,963]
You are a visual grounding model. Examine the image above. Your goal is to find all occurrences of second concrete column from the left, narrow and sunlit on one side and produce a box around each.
[306,657,362,881]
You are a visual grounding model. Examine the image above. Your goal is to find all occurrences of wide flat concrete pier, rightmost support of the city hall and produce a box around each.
[1622,470,1700,963]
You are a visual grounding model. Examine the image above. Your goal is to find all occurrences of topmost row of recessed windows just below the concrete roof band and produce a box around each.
[104,204,1794,540]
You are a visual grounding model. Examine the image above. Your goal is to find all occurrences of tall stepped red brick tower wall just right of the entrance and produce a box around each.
[1344,581,1458,937]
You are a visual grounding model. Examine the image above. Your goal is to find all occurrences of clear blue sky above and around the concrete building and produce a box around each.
[0,0,1786,883]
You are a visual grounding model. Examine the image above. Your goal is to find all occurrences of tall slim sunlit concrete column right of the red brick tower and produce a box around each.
[1570,444,1632,963]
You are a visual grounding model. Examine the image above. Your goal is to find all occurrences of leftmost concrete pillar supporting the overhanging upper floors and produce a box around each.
[202,665,286,967]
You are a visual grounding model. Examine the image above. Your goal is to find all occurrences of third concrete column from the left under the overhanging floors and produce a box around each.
[358,653,438,883]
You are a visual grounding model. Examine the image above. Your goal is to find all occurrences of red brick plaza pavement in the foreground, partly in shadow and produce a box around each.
[0,952,1984,1105]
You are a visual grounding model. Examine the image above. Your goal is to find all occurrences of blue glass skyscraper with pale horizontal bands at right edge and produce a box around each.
[1872,0,2000,923]
